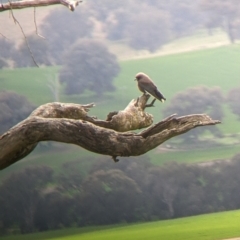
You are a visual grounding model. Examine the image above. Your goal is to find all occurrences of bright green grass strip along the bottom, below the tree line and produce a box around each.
[2,210,240,240]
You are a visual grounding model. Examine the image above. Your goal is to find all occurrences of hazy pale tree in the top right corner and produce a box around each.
[201,0,240,43]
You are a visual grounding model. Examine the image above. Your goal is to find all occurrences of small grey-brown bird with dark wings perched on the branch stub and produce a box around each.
[135,72,166,102]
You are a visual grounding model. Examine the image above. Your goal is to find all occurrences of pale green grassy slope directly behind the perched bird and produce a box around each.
[0,44,240,121]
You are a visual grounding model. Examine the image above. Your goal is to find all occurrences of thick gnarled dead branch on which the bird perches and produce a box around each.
[0,95,220,169]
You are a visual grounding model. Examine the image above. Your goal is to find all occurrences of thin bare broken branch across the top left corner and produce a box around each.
[0,0,81,12]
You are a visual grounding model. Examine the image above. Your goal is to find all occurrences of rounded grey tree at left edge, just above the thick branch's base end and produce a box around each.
[0,91,35,134]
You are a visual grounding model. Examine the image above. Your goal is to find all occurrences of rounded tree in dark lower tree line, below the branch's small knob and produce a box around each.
[81,170,141,224]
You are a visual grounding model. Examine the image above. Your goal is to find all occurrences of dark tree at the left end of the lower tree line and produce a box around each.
[0,166,53,233]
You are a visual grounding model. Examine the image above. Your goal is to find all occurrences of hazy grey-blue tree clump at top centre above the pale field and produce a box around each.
[89,0,203,49]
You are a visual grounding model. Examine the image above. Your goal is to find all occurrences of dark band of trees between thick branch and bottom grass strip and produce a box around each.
[0,154,240,234]
